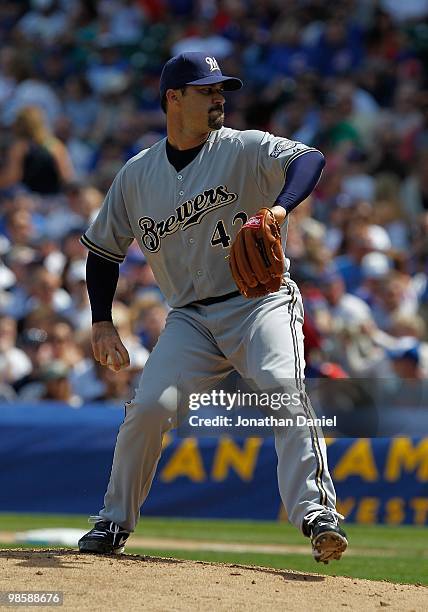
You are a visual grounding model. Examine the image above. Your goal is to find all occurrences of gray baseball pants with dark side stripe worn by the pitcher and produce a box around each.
[100,280,336,532]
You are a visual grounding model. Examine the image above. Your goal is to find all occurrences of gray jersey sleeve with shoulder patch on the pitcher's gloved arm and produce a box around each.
[244,130,318,199]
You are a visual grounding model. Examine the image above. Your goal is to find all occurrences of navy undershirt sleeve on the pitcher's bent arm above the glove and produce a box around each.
[275,151,325,214]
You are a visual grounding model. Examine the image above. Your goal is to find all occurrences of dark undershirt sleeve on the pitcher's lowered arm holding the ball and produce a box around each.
[86,251,119,323]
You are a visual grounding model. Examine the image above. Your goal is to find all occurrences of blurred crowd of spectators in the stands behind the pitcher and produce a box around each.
[0,0,428,407]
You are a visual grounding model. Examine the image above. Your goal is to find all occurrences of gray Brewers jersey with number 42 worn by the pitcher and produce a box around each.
[82,128,320,307]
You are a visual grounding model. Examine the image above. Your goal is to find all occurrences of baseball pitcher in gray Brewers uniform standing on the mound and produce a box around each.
[79,52,347,563]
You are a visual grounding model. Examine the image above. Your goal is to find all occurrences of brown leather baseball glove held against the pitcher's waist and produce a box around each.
[229,208,285,298]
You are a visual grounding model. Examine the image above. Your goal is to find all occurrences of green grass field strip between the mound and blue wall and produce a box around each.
[0,513,428,585]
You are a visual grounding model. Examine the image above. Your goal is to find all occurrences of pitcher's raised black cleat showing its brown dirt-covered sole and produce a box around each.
[303,508,348,564]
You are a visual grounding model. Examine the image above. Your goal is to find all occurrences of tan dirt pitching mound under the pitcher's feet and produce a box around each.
[0,549,428,612]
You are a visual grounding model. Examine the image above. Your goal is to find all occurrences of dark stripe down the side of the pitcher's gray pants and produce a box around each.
[287,285,327,506]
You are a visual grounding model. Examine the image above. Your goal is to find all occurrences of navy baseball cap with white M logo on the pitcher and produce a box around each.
[159,51,242,99]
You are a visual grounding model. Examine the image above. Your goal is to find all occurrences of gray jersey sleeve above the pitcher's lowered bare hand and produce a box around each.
[80,166,134,263]
